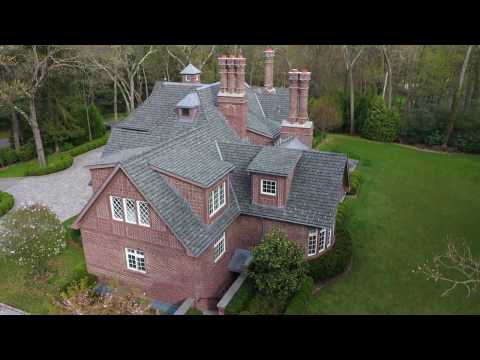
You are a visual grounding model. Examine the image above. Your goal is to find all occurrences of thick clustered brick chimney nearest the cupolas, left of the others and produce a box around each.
[218,53,248,138]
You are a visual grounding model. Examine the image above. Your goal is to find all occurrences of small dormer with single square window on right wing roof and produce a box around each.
[247,146,302,208]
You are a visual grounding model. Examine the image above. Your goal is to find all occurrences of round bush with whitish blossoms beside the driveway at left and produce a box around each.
[0,204,66,275]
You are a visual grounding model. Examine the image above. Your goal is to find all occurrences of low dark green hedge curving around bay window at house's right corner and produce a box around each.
[309,228,352,281]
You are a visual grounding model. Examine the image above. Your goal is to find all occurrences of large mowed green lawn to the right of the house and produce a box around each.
[310,135,480,314]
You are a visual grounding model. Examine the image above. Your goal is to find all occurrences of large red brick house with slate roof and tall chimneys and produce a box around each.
[73,49,349,309]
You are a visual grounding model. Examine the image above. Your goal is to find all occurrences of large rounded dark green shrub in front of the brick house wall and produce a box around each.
[248,228,307,302]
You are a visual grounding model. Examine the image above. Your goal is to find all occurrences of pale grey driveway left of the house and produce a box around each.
[0,147,103,221]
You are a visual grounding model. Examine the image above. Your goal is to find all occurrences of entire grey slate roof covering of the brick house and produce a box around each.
[83,78,346,256]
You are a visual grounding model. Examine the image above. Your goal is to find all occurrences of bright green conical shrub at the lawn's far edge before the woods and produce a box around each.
[361,96,400,142]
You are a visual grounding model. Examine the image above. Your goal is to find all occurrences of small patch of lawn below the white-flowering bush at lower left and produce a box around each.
[0,218,85,314]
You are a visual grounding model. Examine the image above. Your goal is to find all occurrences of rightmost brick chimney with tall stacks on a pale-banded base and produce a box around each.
[280,69,313,148]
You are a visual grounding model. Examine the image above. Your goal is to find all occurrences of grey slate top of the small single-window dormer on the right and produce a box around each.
[247,147,302,176]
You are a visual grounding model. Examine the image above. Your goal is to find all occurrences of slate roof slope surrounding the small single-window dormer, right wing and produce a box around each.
[219,143,347,227]
